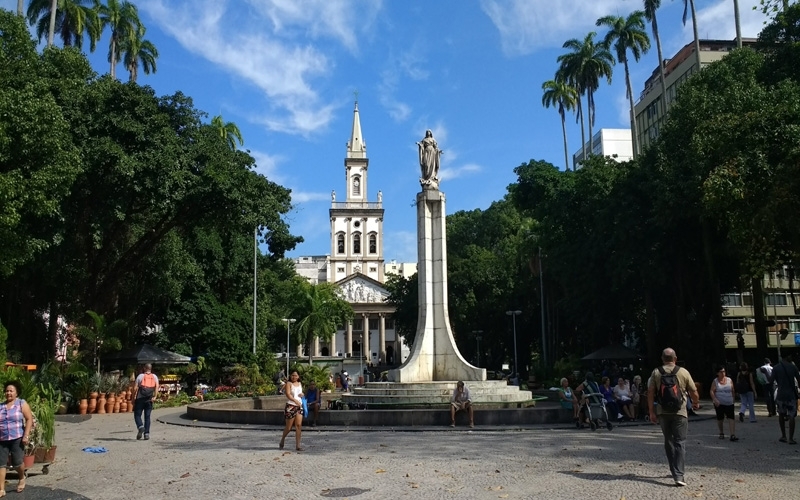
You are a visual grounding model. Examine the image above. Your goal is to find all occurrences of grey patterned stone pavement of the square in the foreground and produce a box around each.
[6,402,800,500]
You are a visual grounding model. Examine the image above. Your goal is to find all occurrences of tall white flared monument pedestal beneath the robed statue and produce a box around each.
[389,186,486,383]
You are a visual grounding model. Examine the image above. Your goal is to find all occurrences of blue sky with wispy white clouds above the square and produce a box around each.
[0,0,765,262]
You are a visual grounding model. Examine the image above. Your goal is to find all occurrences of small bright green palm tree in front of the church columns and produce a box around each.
[294,283,353,364]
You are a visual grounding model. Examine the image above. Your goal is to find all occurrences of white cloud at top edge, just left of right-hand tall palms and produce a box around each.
[481,0,641,55]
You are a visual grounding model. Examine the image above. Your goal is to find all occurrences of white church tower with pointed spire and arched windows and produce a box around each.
[328,101,384,283]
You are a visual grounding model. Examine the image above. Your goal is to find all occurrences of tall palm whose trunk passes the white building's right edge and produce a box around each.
[597,10,650,158]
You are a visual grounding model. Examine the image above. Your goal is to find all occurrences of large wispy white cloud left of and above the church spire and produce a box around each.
[139,0,381,135]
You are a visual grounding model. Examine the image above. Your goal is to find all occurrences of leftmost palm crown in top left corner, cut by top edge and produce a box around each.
[27,0,100,51]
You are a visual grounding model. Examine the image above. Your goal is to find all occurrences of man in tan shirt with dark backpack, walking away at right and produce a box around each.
[647,347,700,486]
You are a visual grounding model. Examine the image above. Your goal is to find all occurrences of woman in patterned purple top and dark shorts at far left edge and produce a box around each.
[0,382,33,497]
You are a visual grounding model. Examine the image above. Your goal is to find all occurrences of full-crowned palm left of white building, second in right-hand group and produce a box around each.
[557,31,614,160]
